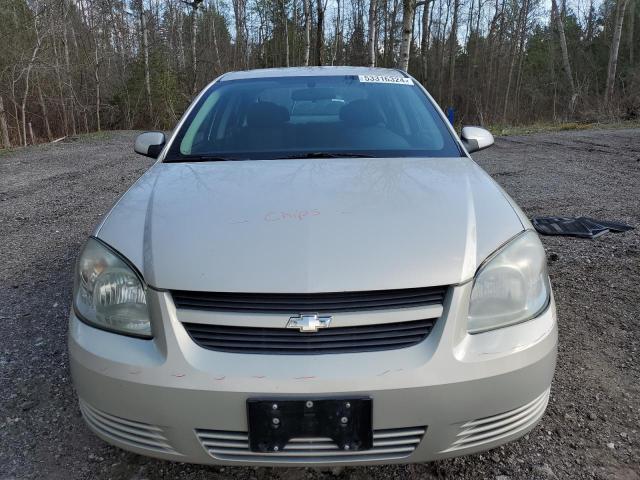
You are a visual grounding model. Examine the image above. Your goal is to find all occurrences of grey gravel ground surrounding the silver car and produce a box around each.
[0,130,640,480]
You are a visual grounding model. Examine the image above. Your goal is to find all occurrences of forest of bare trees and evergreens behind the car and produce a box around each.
[0,0,640,148]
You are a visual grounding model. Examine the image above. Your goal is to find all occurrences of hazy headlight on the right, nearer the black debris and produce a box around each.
[468,231,551,333]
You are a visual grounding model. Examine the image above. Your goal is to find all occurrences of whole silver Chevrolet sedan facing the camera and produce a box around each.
[69,67,557,465]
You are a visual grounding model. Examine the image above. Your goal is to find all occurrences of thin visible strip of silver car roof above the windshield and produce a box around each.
[220,67,407,81]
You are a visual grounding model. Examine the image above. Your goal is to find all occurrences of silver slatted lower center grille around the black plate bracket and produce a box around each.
[196,427,426,463]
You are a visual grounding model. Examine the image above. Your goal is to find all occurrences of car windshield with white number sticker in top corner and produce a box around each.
[165,75,461,161]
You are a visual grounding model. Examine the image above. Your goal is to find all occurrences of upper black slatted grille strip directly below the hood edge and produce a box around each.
[171,287,447,314]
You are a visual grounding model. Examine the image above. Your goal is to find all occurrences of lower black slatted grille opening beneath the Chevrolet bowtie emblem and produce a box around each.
[183,319,436,355]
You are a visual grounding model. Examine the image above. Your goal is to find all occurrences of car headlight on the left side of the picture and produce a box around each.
[73,238,151,337]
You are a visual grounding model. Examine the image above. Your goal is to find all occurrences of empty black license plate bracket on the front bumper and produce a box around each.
[247,397,373,453]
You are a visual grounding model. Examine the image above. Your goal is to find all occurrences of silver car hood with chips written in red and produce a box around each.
[96,158,523,293]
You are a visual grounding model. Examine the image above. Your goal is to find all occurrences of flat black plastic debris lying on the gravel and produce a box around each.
[531,217,634,238]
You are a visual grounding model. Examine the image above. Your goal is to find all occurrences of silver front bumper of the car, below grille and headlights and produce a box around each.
[69,283,557,465]
